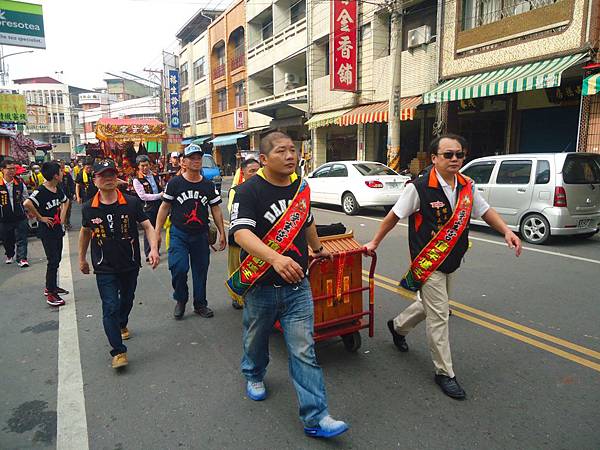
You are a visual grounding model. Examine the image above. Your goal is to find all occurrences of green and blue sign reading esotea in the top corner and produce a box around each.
[0,0,46,48]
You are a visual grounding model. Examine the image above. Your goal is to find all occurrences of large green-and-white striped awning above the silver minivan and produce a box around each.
[423,53,586,103]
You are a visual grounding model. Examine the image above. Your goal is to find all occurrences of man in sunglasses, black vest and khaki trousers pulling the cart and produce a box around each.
[366,134,521,400]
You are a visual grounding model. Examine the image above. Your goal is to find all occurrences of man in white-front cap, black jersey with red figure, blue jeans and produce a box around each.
[155,144,226,320]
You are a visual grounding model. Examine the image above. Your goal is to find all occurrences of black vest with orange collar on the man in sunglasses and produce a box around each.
[408,168,471,273]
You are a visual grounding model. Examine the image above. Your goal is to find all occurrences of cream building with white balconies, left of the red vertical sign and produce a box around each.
[246,0,310,145]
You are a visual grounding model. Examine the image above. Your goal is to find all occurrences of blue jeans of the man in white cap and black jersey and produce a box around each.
[169,225,210,308]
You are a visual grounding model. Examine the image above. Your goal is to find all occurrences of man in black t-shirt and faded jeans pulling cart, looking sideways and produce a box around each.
[229,132,348,438]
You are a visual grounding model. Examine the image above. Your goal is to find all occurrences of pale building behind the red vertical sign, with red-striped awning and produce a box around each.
[306,0,438,168]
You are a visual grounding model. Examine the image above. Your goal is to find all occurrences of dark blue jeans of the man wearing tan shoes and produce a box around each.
[96,270,139,356]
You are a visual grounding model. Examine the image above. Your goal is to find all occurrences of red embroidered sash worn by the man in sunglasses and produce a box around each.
[400,180,473,292]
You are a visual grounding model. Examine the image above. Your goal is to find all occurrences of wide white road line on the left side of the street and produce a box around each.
[56,233,89,450]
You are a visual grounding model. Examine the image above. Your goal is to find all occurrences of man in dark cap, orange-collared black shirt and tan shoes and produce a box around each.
[79,160,159,369]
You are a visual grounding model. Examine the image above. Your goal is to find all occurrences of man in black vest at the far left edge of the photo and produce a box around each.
[0,158,29,267]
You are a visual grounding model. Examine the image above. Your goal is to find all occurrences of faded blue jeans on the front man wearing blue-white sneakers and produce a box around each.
[242,278,329,427]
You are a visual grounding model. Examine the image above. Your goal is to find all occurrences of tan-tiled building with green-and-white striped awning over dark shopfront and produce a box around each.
[424,0,600,157]
